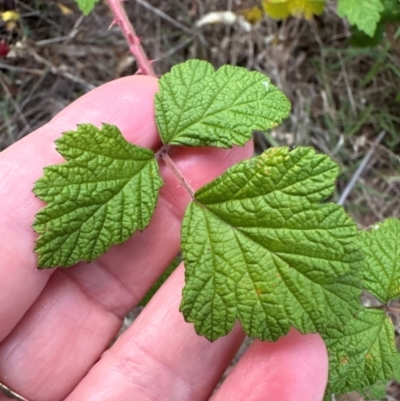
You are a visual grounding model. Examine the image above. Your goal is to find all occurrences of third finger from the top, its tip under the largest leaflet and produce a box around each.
[66,265,245,401]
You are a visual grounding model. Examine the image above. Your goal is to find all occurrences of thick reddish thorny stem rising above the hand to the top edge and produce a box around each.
[107,0,157,77]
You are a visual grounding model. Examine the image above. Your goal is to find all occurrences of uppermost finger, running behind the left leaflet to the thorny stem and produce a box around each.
[0,77,159,341]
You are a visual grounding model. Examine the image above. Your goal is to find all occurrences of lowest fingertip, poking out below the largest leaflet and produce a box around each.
[211,329,328,401]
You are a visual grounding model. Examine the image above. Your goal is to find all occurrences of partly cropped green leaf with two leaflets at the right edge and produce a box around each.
[323,219,400,394]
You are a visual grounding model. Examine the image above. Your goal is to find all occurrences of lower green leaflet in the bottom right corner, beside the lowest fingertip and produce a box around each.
[324,309,396,394]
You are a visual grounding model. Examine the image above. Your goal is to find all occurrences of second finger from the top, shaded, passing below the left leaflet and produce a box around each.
[0,76,251,400]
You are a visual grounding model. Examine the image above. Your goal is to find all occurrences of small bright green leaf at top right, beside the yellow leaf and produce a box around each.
[338,0,384,36]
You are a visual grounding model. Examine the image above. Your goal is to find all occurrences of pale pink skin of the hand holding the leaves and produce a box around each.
[0,76,328,401]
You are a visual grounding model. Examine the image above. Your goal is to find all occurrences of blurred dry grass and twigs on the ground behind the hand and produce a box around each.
[0,0,400,401]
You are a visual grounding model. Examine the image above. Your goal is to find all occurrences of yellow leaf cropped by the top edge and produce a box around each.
[262,0,325,19]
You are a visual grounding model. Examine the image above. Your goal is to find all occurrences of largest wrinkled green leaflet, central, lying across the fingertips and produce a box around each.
[181,148,362,340]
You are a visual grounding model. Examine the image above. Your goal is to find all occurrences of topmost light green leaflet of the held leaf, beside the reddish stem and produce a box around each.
[155,60,290,148]
